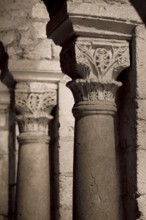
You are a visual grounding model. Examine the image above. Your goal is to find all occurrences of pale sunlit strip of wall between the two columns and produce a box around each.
[58,76,74,220]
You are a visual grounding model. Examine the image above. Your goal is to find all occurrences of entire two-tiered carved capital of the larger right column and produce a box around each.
[60,39,130,102]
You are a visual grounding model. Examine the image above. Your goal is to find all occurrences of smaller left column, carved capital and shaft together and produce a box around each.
[15,82,56,220]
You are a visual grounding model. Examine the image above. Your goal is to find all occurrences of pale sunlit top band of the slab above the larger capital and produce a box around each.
[68,0,142,23]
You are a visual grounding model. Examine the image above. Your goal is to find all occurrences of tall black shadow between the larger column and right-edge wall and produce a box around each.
[116,43,140,220]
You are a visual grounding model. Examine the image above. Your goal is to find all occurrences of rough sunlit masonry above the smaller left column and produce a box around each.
[0,0,59,71]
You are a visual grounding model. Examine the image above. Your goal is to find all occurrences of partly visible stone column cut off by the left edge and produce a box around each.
[0,82,10,220]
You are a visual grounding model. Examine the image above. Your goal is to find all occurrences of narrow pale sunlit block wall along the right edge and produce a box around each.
[135,26,146,220]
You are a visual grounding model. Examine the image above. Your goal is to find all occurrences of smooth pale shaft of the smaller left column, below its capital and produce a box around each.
[17,137,50,220]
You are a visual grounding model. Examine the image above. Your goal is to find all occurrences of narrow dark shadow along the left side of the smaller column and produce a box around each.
[0,41,16,220]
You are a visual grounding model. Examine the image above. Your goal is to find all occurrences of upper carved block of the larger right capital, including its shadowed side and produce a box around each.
[60,38,130,81]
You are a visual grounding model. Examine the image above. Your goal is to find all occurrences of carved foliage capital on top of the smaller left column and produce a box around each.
[15,82,56,133]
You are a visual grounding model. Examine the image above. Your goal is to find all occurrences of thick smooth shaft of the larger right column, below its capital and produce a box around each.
[73,104,120,220]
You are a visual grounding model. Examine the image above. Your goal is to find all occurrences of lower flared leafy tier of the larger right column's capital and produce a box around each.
[67,79,122,103]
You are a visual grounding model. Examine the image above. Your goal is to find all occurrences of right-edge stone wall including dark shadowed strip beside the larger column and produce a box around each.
[118,25,146,220]
